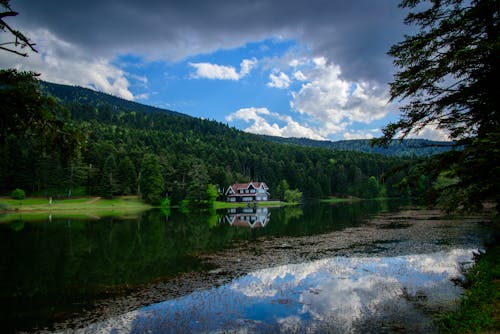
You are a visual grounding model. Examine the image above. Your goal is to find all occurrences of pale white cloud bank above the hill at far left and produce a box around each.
[0,30,134,100]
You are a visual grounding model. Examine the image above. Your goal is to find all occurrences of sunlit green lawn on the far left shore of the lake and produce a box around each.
[0,196,152,221]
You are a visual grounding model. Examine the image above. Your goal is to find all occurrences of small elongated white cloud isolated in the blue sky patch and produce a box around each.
[189,58,257,81]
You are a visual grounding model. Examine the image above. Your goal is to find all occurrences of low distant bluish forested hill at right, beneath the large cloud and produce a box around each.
[266,136,453,157]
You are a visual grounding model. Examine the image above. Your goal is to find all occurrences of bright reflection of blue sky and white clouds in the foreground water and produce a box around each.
[85,249,474,333]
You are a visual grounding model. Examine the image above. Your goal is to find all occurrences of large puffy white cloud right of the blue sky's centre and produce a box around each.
[290,57,389,137]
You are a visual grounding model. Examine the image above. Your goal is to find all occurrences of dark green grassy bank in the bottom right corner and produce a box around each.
[439,245,500,333]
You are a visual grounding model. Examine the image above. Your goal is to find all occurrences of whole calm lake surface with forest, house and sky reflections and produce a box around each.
[0,201,492,333]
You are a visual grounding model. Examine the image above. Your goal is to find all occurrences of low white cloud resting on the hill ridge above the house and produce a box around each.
[226,108,325,140]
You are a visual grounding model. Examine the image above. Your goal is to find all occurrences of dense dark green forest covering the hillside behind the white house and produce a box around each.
[0,83,422,203]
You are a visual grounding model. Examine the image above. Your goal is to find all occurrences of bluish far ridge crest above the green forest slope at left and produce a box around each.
[40,81,191,117]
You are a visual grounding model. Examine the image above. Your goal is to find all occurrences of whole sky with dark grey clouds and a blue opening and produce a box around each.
[0,0,446,140]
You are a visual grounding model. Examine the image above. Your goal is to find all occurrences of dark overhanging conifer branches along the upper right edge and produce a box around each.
[375,0,500,210]
